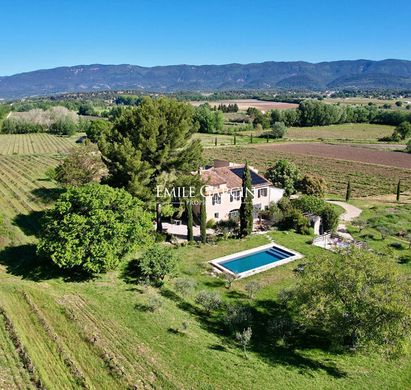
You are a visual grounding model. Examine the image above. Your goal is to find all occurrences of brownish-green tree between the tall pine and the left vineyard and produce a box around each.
[54,145,107,186]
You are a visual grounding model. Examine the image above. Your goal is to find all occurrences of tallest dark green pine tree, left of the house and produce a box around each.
[98,97,202,232]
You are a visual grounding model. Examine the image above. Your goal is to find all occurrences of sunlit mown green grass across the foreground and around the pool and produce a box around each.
[0,232,411,389]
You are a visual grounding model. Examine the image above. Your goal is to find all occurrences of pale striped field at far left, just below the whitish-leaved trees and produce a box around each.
[0,133,78,155]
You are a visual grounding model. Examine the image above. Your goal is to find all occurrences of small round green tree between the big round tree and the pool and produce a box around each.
[138,245,177,285]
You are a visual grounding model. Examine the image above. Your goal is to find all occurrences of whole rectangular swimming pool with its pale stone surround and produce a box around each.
[210,243,303,278]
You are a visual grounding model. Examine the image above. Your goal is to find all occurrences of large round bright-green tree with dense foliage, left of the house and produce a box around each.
[37,184,152,273]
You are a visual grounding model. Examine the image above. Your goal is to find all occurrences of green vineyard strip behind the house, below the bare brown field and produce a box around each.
[204,143,411,197]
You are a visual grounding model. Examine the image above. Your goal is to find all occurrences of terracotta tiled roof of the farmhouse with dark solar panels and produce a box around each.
[201,165,271,188]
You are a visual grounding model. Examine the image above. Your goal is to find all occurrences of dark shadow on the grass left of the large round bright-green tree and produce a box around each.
[0,244,92,282]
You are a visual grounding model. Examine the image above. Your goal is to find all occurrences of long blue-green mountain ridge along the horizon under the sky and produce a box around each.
[0,59,411,98]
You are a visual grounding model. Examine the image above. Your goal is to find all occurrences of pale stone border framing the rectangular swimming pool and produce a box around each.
[209,242,304,279]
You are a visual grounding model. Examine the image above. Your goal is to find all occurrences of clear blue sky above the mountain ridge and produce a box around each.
[0,0,411,75]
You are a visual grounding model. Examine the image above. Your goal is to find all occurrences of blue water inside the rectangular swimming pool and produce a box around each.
[219,246,294,274]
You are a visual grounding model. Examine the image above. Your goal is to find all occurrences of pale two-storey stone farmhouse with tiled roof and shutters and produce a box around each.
[198,160,284,222]
